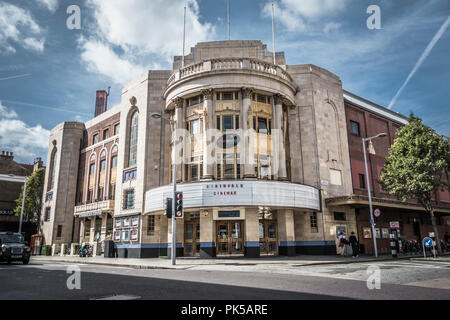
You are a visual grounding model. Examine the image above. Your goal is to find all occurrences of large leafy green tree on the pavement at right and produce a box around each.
[380,114,450,253]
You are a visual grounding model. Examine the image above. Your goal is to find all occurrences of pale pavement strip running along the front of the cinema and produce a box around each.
[31,254,450,270]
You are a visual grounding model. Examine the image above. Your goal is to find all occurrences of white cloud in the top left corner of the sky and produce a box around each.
[0,2,45,54]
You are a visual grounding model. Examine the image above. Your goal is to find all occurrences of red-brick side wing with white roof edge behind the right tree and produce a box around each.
[327,92,450,253]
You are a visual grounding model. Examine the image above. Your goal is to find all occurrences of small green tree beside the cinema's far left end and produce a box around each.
[14,168,45,224]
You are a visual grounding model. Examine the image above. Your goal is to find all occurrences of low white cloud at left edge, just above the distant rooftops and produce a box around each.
[0,101,50,162]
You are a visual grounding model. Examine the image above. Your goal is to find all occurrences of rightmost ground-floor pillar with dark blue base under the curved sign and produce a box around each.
[277,209,295,257]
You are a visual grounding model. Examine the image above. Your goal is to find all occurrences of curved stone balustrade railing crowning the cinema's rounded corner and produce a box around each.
[167,58,292,86]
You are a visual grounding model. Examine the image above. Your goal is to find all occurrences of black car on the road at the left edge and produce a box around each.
[0,232,31,264]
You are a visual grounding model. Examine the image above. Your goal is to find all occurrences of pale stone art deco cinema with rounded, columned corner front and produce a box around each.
[42,41,376,258]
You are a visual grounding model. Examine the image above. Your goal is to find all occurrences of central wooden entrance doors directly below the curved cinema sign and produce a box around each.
[217,221,244,255]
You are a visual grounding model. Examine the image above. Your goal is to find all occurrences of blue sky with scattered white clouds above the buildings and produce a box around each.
[0,0,450,163]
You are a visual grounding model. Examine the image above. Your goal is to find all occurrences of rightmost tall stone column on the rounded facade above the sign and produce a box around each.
[272,94,287,180]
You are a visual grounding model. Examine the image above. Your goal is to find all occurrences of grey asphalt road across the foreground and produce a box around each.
[0,261,450,300]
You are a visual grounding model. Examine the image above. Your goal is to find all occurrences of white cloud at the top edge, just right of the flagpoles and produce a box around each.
[262,0,348,32]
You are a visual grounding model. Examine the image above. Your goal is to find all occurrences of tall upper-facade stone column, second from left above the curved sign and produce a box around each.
[202,89,215,180]
